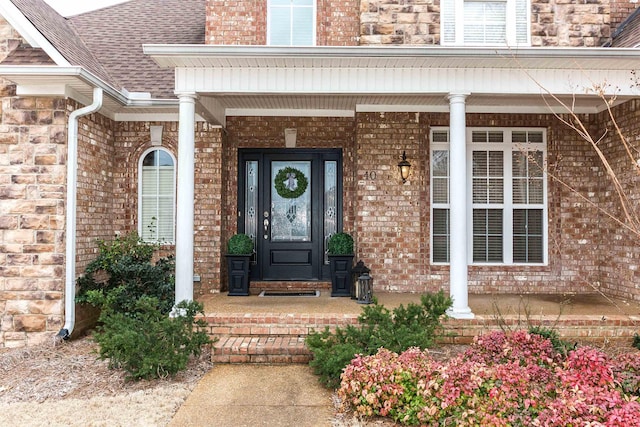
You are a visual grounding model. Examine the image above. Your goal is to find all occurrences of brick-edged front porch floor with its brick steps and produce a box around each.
[199,290,640,363]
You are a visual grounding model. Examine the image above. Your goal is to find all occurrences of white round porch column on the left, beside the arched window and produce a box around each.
[176,93,196,304]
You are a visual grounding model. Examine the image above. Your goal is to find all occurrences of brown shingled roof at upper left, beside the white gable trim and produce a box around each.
[12,0,206,98]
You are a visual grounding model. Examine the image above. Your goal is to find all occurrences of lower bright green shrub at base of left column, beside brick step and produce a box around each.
[94,288,211,380]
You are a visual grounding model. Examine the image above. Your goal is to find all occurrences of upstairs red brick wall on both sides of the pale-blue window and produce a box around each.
[205,0,359,46]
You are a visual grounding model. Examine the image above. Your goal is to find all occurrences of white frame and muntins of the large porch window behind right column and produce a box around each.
[429,127,549,266]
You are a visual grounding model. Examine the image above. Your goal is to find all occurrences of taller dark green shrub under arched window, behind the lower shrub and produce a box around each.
[76,232,175,314]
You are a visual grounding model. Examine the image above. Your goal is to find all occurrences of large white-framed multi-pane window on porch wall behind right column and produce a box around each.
[431,129,547,264]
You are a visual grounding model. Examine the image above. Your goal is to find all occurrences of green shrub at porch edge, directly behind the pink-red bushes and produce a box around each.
[306,291,452,388]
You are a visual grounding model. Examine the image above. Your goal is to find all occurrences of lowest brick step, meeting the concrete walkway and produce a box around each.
[211,336,311,364]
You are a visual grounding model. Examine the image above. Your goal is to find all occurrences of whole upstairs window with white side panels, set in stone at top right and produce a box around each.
[440,0,531,46]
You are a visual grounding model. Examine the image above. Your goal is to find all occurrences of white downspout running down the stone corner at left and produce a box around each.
[56,88,103,340]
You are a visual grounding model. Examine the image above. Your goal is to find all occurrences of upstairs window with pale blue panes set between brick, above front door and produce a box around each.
[267,0,316,46]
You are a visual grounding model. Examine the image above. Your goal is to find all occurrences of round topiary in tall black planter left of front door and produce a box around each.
[226,233,254,296]
